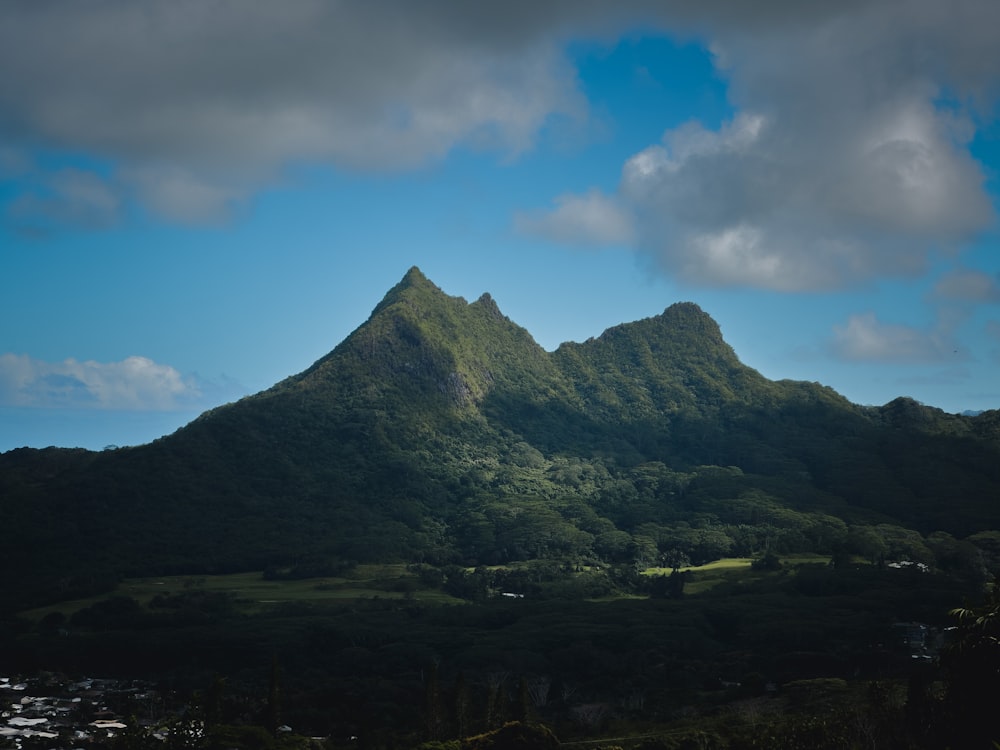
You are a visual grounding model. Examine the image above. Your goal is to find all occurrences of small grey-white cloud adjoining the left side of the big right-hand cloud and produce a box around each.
[514,189,634,246]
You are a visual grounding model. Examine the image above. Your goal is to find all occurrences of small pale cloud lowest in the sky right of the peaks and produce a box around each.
[831,312,966,363]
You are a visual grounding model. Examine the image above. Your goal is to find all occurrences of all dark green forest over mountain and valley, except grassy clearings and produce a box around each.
[0,268,1000,748]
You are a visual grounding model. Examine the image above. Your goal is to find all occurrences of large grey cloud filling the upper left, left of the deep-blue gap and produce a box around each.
[0,0,586,221]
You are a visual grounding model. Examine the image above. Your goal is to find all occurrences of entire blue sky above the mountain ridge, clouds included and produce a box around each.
[0,0,1000,451]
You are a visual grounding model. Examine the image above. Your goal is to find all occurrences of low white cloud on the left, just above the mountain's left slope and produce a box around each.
[0,353,225,411]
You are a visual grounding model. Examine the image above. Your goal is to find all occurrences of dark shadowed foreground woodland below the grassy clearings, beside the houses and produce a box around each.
[0,565,1000,750]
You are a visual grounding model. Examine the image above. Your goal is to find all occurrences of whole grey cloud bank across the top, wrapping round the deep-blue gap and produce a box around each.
[0,0,1000,291]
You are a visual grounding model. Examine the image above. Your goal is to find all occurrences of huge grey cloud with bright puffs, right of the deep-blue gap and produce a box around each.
[520,0,1000,291]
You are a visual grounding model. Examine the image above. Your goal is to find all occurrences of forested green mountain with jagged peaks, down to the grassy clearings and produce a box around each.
[0,268,1000,606]
